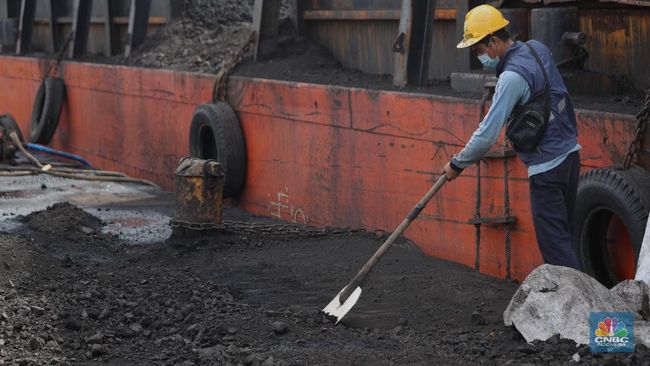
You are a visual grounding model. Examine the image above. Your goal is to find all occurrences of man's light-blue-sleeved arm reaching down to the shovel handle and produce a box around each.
[443,71,530,180]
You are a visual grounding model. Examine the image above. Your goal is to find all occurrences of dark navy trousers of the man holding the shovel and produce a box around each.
[529,152,580,269]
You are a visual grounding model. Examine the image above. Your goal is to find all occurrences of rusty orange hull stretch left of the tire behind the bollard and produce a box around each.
[0,56,213,184]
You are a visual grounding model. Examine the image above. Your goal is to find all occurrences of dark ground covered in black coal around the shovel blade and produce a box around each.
[0,196,650,366]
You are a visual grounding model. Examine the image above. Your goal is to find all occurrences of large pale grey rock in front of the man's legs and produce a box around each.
[503,264,650,345]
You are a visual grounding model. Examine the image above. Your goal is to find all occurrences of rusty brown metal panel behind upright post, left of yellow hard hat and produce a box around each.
[305,0,456,79]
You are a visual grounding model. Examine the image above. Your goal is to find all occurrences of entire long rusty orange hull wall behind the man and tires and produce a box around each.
[0,57,635,280]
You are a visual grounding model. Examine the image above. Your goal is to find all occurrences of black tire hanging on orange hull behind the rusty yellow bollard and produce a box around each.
[190,102,246,198]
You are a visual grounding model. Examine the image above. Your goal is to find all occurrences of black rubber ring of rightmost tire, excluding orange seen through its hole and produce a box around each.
[574,167,650,287]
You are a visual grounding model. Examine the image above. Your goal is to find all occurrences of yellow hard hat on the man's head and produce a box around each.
[456,5,510,48]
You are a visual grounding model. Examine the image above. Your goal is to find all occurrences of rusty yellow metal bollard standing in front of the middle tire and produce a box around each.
[174,157,225,229]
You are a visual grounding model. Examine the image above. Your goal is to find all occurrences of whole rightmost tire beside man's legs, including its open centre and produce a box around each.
[574,167,650,287]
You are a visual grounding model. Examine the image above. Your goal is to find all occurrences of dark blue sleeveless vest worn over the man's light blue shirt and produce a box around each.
[496,40,578,166]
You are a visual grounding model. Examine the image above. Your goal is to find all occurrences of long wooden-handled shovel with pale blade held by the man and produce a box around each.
[323,174,447,324]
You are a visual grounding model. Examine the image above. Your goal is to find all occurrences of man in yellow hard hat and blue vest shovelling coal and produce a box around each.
[443,5,581,269]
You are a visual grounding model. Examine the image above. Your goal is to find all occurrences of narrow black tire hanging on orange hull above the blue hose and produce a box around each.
[30,76,65,145]
